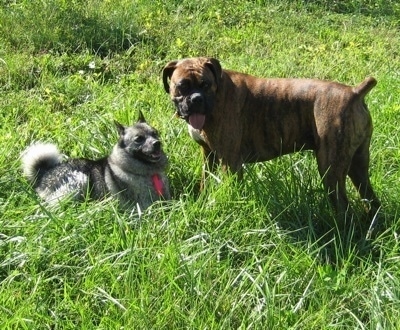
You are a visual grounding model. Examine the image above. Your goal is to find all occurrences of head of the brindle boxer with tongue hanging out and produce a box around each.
[163,57,222,129]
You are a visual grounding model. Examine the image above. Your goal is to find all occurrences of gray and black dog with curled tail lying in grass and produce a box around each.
[22,112,170,210]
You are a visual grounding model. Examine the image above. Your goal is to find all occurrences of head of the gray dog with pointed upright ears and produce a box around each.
[115,111,167,165]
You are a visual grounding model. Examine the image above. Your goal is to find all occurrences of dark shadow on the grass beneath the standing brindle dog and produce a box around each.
[239,164,395,264]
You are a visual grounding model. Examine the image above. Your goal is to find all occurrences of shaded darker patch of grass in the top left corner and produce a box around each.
[0,1,146,57]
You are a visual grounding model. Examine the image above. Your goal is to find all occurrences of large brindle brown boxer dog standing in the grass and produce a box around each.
[163,57,380,216]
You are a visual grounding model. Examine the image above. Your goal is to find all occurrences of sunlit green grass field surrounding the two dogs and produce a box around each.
[0,0,400,329]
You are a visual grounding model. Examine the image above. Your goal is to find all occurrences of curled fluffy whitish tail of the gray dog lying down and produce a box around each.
[21,143,62,183]
